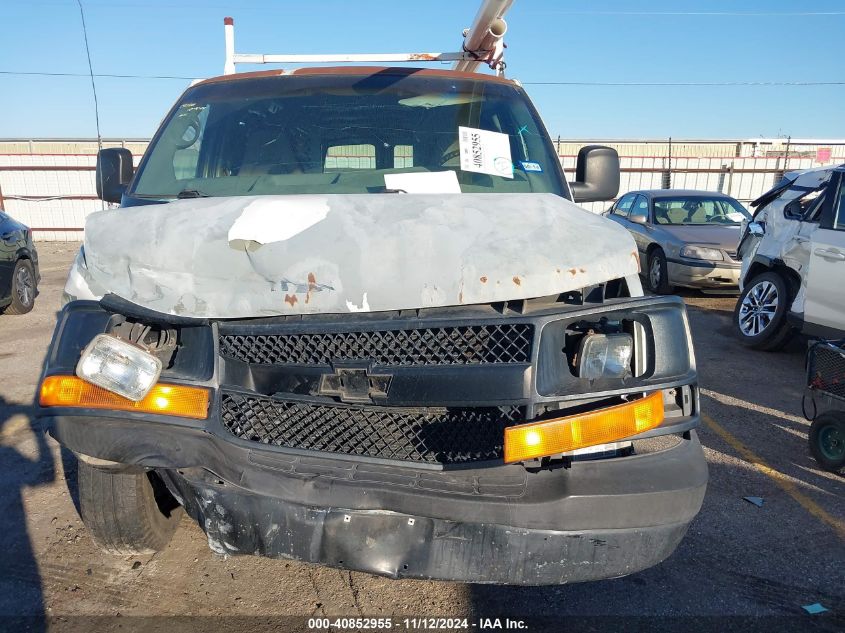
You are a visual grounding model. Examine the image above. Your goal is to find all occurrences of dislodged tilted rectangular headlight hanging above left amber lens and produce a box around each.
[76,334,161,402]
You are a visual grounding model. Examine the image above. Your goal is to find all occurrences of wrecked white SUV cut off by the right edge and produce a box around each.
[734,165,845,350]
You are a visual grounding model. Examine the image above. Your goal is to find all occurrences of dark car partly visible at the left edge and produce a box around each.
[0,211,41,314]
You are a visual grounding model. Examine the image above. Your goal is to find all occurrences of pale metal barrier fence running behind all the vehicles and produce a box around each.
[0,138,845,241]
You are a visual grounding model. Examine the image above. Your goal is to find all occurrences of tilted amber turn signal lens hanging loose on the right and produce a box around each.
[505,391,665,463]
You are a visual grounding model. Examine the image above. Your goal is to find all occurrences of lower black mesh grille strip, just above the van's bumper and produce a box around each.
[222,392,524,464]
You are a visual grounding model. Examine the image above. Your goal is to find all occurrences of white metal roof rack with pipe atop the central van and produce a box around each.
[223,0,514,76]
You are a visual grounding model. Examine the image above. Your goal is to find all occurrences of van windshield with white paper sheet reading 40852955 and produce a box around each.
[129,70,569,198]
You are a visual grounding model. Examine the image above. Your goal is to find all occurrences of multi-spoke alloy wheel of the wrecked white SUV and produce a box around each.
[734,271,794,352]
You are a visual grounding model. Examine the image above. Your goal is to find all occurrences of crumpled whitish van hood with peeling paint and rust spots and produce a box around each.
[81,194,639,318]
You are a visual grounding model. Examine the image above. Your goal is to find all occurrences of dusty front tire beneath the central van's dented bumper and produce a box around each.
[77,461,182,556]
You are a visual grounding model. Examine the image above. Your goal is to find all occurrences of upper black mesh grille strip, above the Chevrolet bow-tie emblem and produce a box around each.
[220,323,534,366]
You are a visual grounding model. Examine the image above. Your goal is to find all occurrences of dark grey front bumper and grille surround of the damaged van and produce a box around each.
[39,298,707,584]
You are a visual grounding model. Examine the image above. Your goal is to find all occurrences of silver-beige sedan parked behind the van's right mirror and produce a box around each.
[605,189,751,294]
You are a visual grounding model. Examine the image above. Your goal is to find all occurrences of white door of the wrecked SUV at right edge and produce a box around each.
[804,172,845,335]
